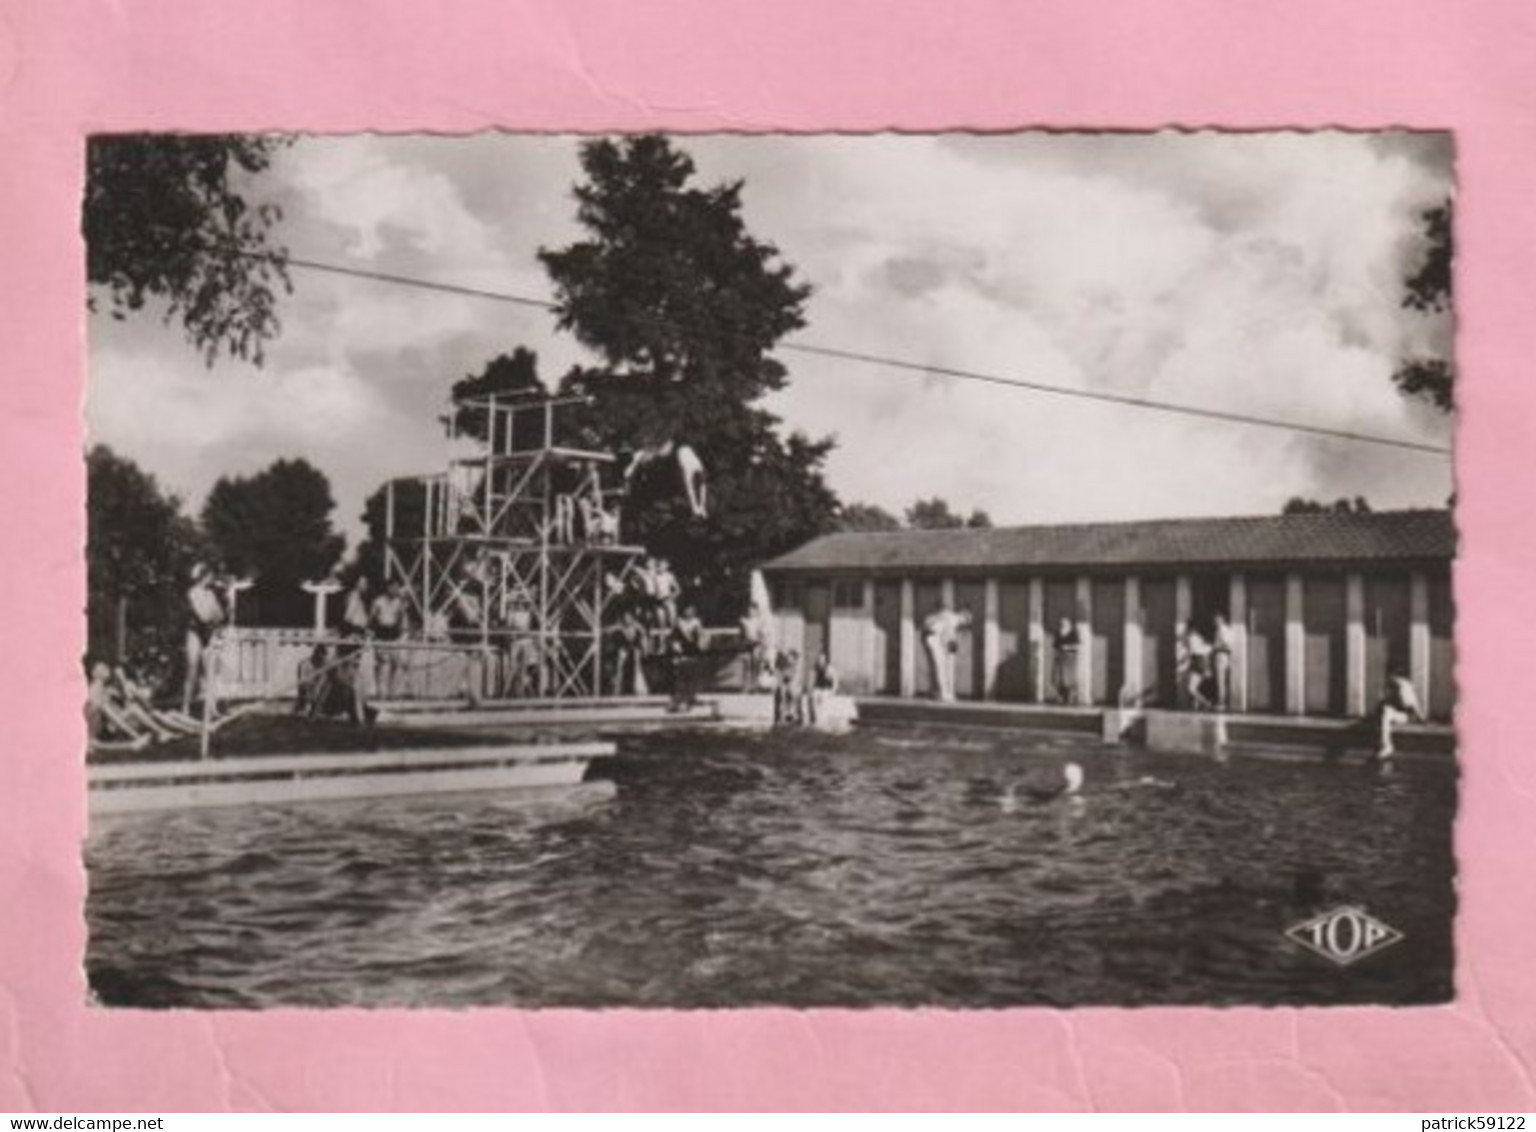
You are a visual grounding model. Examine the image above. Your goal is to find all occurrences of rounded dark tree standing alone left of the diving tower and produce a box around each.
[203,459,344,625]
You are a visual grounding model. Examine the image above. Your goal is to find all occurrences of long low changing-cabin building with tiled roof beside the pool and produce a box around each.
[763,510,1456,717]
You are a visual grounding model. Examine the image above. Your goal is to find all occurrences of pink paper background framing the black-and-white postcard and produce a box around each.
[0,0,1536,1112]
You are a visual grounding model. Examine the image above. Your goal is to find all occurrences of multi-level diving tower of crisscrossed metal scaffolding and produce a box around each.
[384,395,645,699]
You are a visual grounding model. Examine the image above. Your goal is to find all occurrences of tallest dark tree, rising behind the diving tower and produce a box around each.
[539,135,837,617]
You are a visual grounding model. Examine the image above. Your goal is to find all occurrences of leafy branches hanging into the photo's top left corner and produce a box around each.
[83,134,292,364]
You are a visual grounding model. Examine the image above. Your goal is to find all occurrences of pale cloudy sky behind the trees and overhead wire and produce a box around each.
[88,134,1452,535]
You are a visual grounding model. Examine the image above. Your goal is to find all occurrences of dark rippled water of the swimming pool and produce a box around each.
[88,731,1455,1008]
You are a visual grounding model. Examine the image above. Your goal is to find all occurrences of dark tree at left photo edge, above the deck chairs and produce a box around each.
[86,445,200,682]
